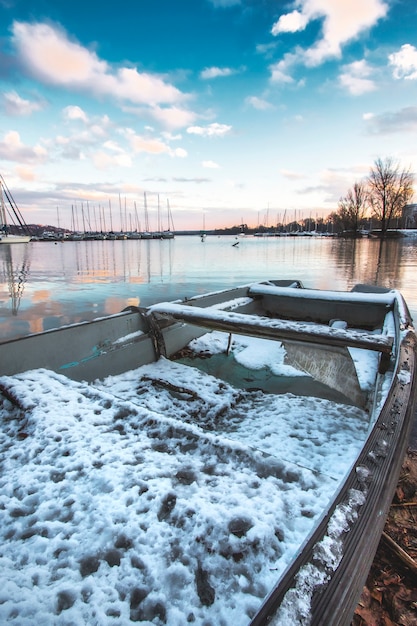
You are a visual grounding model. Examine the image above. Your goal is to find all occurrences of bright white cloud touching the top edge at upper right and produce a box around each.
[272,0,388,66]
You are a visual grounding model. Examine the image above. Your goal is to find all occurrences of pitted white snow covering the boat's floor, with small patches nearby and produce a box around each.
[0,333,382,626]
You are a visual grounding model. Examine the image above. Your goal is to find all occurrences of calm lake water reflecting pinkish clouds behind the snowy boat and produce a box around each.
[0,236,417,341]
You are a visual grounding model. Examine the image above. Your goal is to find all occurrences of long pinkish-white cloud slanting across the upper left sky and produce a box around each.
[13,22,187,106]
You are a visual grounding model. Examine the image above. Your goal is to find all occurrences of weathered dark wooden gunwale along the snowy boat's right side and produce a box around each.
[249,304,417,626]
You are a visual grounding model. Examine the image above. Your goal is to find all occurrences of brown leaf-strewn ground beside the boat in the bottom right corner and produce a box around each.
[351,449,417,626]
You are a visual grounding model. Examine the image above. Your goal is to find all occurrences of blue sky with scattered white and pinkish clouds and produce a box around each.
[0,0,417,229]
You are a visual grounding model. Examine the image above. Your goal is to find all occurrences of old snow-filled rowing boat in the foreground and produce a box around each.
[0,280,417,626]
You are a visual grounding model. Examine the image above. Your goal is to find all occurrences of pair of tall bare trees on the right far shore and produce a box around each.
[329,157,414,238]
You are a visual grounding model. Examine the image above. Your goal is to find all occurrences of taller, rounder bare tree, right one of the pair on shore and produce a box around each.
[367,157,414,238]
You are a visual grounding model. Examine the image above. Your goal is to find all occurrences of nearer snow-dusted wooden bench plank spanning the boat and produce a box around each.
[148,302,393,355]
